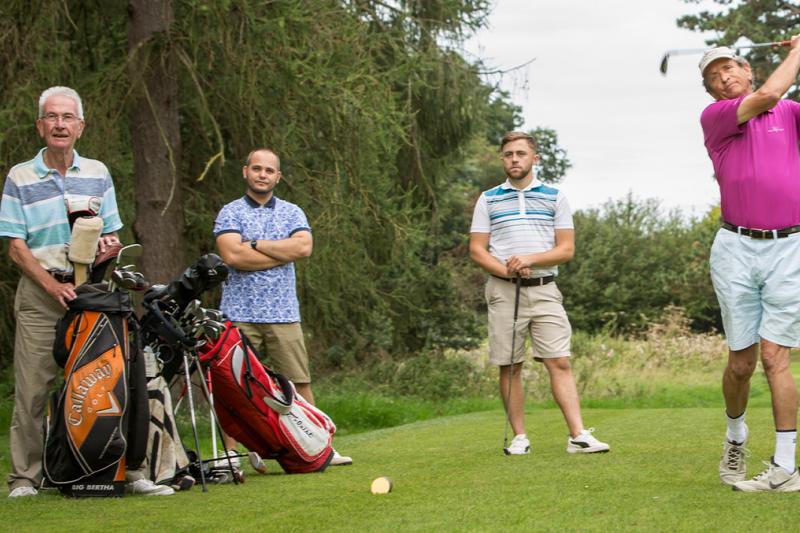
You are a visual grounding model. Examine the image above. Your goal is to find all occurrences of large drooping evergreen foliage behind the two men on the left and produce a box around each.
[0,0,518,365]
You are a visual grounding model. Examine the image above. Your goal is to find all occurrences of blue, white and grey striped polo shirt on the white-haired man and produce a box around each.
[0,148,122,272]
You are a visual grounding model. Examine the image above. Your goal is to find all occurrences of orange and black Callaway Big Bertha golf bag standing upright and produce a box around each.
[43,284,150,497]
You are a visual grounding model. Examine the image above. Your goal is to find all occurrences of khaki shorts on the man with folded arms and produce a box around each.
[235,322,311,384]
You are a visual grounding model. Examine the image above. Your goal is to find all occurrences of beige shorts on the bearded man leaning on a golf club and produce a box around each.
[486,277,572,365]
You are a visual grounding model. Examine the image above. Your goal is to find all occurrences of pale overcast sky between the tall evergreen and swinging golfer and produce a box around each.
[466,0,719,215]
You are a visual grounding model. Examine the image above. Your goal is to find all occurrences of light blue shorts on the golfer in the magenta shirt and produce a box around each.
[711,229,800,350]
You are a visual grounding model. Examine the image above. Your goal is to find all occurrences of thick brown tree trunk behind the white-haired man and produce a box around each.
[128,0,186,282]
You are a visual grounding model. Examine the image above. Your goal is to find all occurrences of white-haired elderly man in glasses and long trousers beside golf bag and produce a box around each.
[0,87,122,497]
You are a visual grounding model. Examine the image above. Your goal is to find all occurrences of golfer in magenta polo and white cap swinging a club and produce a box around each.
[700,35,800,492]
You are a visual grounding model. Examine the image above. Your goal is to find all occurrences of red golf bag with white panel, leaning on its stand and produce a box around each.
[197,321,336,474]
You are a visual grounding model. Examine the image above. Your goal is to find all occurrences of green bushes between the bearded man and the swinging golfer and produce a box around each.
[558,196,721,333]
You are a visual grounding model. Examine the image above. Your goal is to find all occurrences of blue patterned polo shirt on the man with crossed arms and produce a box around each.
[214,195,311,324]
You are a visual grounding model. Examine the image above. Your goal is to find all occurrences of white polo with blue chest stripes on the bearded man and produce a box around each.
[470,178,574,277]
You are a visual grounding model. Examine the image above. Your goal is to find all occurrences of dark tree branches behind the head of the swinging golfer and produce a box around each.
[678,0,800,100]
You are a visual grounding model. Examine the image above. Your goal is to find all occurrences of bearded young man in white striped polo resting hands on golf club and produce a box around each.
[469,132,610,455]
